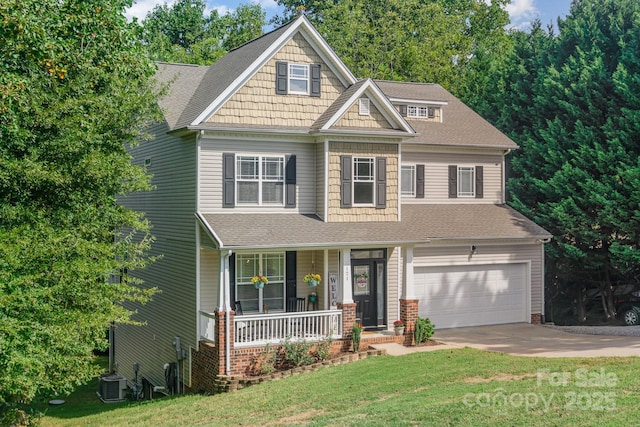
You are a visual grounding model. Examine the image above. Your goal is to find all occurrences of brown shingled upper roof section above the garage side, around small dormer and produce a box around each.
[375,80,518,149]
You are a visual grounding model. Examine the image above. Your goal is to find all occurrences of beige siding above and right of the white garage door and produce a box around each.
[413,242,544,314]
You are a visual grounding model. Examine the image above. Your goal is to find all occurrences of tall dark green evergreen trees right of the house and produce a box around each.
[480,0,640,321]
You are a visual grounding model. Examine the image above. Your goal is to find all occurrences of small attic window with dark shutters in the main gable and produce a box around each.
[276,62,322,96]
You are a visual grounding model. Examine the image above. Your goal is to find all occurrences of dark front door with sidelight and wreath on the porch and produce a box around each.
[351,251,386,329]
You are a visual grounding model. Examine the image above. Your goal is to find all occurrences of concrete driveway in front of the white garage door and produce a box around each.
[430,323,640,357]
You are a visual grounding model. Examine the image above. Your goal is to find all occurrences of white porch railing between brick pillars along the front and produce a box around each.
[235,310,342,347]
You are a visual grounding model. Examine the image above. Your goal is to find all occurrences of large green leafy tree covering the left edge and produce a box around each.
[0,0,158,425]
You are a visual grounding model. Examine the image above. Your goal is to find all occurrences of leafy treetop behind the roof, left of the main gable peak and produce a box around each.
[139,0,265,65]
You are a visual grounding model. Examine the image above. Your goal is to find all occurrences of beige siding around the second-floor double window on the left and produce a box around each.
[200,137,316,213]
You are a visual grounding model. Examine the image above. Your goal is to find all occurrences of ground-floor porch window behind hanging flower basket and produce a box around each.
[235,252,286,313]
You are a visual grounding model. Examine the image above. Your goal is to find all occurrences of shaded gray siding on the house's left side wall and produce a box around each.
[115,125,197,385]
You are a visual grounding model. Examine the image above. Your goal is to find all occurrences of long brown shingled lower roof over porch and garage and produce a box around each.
[197,204,551,249]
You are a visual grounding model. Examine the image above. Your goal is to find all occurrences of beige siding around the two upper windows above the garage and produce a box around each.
[401,149,504,204]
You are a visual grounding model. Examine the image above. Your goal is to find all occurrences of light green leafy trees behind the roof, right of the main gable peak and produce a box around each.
[277,0,509,92]
